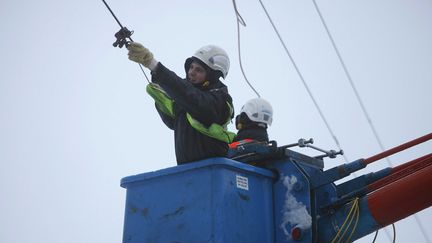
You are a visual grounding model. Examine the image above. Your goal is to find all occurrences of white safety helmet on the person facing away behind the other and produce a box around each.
[240,98,273,126]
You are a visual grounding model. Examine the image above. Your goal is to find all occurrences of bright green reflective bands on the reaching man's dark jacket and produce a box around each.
[146,83,236,143]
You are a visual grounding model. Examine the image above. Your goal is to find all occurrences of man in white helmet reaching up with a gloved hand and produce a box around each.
[127,42,235,164]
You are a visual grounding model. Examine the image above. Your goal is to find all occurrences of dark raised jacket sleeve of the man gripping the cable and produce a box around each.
[152,63,231,126]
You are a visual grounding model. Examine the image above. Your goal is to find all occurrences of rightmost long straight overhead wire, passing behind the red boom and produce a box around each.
[312,0,430,242]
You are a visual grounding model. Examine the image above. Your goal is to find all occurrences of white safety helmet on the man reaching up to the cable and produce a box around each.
[185,45,230,79]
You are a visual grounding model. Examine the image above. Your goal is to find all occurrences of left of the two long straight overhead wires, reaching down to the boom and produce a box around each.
[259,0,348,161]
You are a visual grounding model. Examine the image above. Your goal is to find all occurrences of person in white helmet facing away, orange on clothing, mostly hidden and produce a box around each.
[229,98,273,149]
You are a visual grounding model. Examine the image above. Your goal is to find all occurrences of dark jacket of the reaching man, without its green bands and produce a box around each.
[152,63,233,164]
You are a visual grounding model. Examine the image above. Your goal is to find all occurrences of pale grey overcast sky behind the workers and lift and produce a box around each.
[0,0,432,243]
